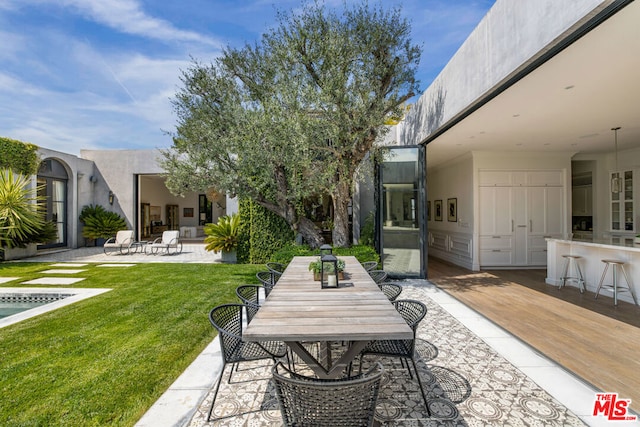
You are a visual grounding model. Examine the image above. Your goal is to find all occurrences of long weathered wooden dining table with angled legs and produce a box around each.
[243,256,413,379]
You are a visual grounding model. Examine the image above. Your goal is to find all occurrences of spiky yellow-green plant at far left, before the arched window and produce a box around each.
[0,169,56,250]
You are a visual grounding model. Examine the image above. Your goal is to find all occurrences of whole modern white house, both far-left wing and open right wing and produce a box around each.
[18,0,640,277]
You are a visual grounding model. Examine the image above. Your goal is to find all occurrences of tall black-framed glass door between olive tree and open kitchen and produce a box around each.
[378,146,426,278]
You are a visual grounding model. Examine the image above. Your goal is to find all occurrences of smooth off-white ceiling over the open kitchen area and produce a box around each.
[427,1,640,167]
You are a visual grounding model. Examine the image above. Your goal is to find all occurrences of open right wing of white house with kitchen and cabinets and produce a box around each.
[370,0,640,280]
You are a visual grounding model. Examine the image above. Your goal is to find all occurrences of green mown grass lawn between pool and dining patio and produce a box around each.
[0,263,264,427]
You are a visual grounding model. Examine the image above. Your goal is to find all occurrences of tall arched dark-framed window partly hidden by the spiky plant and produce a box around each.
[38,159,69,248]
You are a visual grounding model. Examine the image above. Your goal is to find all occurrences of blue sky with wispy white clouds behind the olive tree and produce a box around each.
[0,0,495,155]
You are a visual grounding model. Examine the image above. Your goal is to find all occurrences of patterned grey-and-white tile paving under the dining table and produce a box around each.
[190,286,584,427]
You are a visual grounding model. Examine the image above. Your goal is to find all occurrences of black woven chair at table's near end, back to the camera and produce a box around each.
[272,362,384,427]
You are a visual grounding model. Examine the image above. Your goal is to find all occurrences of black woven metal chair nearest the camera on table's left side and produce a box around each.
[207,304,287,421]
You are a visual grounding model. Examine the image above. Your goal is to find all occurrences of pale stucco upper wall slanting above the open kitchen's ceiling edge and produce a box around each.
[398,0,615,146]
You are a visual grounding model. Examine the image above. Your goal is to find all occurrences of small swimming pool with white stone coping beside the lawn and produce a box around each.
[0,288,111,328]
